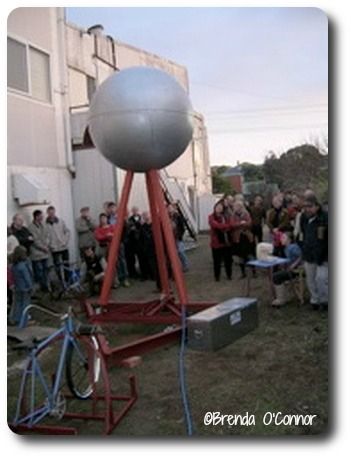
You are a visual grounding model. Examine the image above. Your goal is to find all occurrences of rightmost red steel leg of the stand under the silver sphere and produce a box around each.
[148,170,188,305]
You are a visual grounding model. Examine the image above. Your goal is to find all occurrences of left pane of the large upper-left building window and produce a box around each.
[7,38,29,92]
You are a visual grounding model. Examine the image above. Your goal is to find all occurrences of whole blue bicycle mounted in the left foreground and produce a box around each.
[11,305,101,429]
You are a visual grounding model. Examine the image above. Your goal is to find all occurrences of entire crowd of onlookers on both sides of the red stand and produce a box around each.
[7,189,328,330]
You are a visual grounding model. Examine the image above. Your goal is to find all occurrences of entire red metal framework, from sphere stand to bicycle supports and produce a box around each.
[10,170,215,434]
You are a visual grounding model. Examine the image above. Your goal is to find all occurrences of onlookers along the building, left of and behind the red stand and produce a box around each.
[7,202,189,325]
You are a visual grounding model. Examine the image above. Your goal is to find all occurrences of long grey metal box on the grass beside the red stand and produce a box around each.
[187,297,258,351]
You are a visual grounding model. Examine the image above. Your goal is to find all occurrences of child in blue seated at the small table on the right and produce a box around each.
[272,232,302,307]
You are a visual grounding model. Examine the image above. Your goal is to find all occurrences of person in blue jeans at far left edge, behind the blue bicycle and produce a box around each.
[11,245,33,327]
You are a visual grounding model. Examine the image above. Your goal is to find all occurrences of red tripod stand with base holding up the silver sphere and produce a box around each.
[87,170,214,330]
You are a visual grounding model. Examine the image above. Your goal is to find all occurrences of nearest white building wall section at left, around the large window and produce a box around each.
[7,8,76,256]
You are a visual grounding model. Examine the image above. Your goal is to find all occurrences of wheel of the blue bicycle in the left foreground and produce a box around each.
[66,336,101,399]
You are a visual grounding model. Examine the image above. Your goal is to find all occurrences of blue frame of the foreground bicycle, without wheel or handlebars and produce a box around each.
[14,314,86,427]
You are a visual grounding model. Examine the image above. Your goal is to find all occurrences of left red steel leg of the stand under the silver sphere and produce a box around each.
[99,170,134,305]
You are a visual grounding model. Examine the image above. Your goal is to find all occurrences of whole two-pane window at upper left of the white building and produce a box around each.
[7,37,51,102]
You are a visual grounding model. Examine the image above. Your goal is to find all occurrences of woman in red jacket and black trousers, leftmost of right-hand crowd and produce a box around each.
[208,202,233,281]
